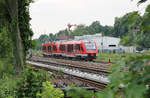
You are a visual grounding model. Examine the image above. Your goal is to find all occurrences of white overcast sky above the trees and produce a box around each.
[30,0,150,38]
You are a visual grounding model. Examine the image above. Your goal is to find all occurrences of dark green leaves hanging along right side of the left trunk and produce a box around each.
[18,0,33,56]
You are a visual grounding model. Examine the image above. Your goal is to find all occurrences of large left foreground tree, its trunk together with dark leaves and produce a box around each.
[0,0,32,73]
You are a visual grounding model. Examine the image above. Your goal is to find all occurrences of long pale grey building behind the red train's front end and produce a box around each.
[75,34,120,51]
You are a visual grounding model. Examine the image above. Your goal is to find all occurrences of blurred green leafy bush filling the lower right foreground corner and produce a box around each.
[99,54,150,98]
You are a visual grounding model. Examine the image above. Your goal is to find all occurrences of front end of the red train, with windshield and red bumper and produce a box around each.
[84,41,98,60]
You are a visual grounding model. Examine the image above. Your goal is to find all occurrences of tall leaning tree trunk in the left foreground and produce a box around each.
[5,0,23,74]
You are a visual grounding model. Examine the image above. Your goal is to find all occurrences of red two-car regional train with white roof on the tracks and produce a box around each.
[42,40,98,60]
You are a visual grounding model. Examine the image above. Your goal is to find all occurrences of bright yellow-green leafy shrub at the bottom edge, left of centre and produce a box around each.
[37,81,64,98]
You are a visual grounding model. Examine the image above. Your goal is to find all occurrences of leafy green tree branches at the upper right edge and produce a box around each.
[120,5,150,49]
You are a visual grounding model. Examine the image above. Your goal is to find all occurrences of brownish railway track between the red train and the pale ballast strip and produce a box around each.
[29,56,111,76]
